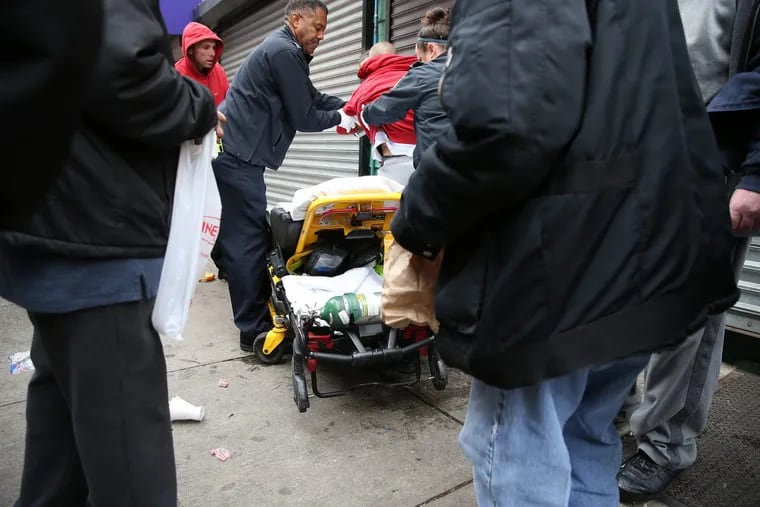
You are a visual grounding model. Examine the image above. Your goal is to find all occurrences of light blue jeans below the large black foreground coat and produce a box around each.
[459,354,649,507]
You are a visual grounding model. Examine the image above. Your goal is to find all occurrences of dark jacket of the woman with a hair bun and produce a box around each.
[362,53,451,167]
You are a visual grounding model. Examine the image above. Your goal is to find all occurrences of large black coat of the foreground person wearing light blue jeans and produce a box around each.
[393,0,738,388]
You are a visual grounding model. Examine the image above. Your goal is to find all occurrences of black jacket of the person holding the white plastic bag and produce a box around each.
[0,0,216,259]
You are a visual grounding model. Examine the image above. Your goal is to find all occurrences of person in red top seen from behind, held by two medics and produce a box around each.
[338,41,417,185]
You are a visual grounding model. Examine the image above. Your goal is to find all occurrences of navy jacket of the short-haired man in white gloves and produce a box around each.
[220,26,345,169]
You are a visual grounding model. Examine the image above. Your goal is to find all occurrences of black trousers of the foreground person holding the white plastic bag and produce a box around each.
[16,300,177,507]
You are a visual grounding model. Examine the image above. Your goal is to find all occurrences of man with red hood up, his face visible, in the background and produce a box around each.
[174,21,230,106]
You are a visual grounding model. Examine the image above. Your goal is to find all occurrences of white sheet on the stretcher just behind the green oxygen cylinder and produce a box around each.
[282,266,383,315]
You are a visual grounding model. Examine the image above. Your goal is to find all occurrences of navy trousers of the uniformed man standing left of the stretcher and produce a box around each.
[213,152,272,335]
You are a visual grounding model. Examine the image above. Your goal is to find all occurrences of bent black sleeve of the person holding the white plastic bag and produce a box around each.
[87,0,217,146]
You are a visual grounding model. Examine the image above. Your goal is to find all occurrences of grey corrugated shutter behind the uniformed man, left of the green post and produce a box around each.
[221,0,362,205]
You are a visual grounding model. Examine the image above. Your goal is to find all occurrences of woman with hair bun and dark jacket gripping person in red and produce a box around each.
[362,7,451,168]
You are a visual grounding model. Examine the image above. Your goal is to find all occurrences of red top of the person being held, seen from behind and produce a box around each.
[339,55,417,146]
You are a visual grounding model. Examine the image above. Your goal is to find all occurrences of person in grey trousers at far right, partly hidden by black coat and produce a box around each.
[617,0,760,502]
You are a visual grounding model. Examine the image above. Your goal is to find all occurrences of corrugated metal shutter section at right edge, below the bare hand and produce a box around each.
[726,238,760,338]
